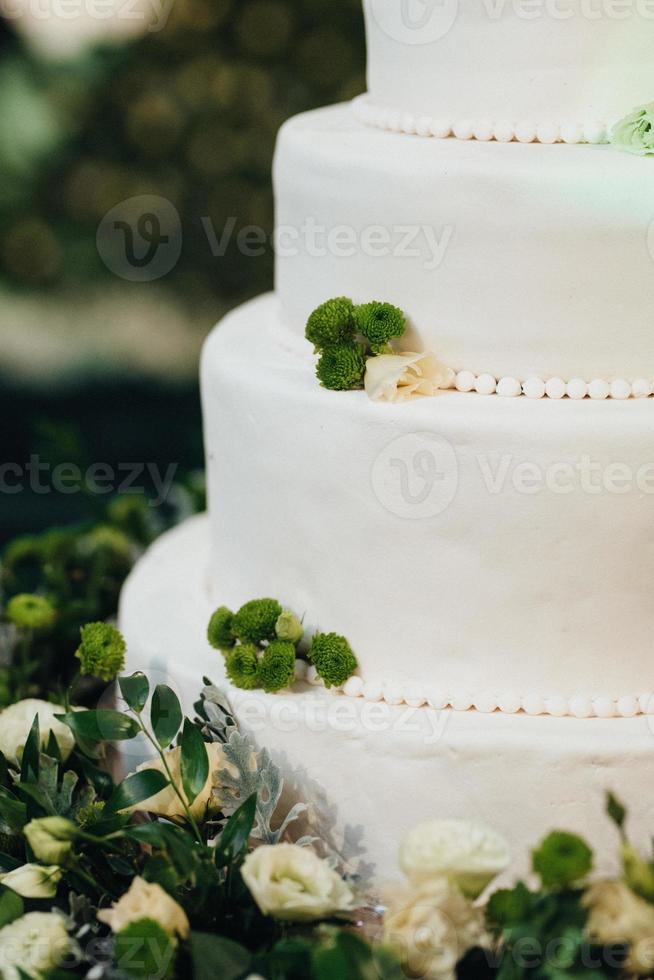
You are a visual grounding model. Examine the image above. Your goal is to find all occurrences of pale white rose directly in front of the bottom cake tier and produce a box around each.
[400,820,510,898]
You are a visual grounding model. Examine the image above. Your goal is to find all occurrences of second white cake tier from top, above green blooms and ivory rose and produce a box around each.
[275,106,654,381]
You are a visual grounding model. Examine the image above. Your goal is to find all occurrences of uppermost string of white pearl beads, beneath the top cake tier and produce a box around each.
[352,95,609,143]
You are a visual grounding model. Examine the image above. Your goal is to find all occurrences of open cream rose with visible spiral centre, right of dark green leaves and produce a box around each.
[241,844,354,922]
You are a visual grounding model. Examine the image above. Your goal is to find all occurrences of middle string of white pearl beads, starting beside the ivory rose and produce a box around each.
[454,371,654,401]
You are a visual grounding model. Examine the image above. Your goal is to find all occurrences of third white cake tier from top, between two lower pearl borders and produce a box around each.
[202,296,654,716]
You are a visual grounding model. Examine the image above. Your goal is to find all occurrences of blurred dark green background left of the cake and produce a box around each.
[0,0,365,544]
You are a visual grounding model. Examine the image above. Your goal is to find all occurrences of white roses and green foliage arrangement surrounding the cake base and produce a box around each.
[0,608,654,980]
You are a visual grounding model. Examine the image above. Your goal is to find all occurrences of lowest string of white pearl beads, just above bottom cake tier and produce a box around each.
[295,660,654,718]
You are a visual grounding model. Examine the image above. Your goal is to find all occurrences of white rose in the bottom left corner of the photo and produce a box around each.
[0,912,74,980]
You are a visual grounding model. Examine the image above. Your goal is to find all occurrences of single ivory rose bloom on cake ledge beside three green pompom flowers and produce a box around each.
[364,353,454,402]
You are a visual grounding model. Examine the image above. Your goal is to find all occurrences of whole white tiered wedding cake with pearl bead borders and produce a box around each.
[121,0,654,878]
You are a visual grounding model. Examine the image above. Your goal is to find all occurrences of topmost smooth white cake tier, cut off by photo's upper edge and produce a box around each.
[364,0,654,133]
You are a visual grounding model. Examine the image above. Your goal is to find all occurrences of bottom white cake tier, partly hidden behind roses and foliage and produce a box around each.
[120,516,654,884]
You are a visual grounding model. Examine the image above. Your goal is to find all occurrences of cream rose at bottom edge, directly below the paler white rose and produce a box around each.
[384,878,487,980]
